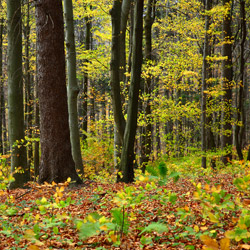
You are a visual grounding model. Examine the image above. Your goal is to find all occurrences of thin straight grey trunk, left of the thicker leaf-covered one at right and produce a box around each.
[201,0,212,168]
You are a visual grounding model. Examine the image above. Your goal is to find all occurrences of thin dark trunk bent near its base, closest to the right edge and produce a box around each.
[235,0,246,160]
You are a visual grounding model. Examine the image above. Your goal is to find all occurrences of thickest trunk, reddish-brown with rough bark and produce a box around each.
[36,0,81,183]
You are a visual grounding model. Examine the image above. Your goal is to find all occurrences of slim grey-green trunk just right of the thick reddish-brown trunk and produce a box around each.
[64,0,84,175]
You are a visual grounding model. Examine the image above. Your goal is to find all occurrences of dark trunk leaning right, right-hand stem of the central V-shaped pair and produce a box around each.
[121,0,144,183]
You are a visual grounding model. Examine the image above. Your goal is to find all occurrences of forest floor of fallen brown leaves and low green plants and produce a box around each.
[0,163,250,250]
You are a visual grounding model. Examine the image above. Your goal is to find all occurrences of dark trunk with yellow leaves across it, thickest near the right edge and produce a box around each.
[221,0,233,164]
